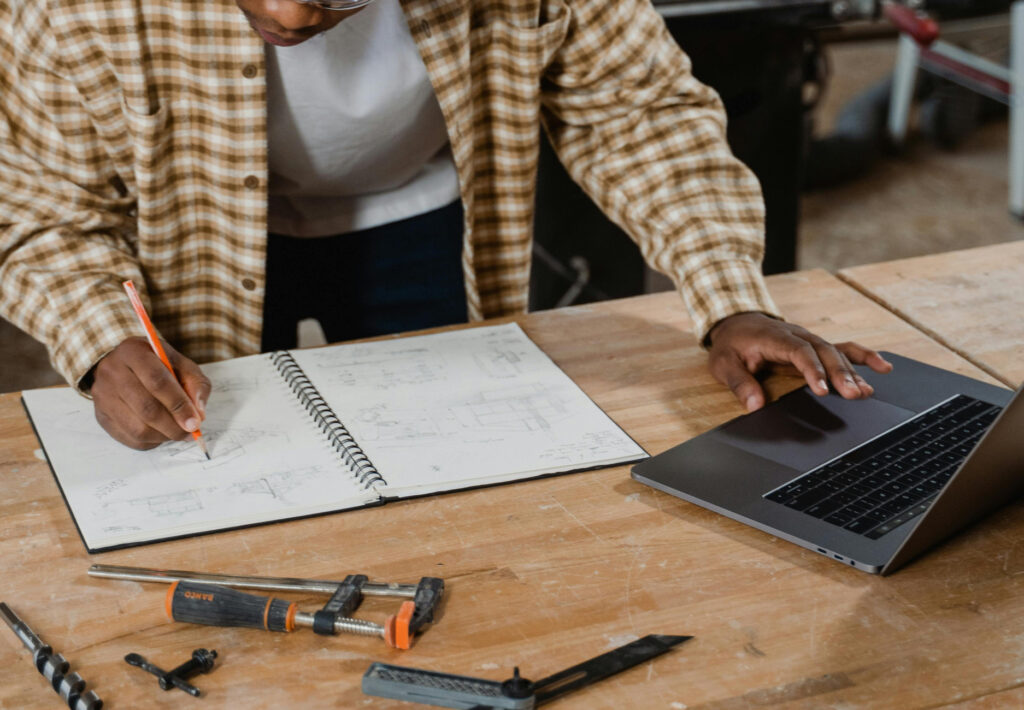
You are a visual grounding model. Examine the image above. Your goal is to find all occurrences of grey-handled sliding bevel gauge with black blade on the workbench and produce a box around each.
[362,634,692,710]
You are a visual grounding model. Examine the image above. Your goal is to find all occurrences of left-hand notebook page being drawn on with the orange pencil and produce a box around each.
[23,356,377,550]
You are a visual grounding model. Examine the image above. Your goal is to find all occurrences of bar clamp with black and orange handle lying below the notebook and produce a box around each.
[89,565,444,649]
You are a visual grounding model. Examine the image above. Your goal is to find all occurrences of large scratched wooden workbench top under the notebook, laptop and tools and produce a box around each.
[0,272,1024,710]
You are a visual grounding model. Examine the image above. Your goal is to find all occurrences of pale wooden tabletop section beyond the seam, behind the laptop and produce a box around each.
[840,242,1024,387]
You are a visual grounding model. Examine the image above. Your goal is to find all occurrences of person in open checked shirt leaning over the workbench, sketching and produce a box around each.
[0,0,889,449]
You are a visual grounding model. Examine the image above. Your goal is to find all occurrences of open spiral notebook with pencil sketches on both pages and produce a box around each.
[23,324,647,552]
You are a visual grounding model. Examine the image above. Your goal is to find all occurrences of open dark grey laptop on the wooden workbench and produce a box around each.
[632,352,1024,575]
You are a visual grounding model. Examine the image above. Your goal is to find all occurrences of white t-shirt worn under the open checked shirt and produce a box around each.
[266,0,459,237]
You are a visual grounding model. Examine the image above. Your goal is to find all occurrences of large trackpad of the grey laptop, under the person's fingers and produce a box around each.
[716,387,915,471]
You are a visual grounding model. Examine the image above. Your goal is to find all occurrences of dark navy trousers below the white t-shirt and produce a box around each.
[262,201,467,351]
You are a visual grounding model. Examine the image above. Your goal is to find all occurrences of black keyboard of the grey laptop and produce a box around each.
[764,394,1001,540]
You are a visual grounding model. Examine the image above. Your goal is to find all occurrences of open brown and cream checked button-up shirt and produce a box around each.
[0,0,775,393]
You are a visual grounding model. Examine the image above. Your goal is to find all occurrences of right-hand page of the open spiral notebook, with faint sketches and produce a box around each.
[291,324,646,497]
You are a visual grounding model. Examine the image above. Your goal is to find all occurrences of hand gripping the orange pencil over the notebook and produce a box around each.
[91,337,210,449]
